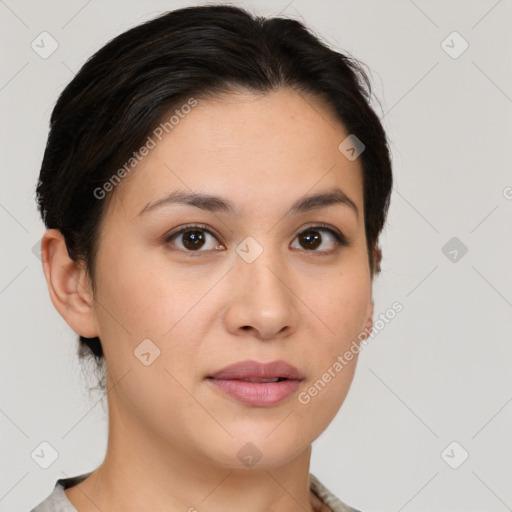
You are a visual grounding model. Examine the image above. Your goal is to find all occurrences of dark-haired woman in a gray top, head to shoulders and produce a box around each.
[34,5,392,512]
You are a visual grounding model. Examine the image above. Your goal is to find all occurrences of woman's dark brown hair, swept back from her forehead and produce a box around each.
[37,5,392,372]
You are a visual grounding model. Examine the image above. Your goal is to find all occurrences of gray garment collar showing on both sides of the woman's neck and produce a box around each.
[30,471,359,512]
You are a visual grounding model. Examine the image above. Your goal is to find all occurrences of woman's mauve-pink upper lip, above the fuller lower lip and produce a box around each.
[209,361,304,382]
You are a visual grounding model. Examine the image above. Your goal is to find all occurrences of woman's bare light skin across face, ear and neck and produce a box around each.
[42,89,373,512]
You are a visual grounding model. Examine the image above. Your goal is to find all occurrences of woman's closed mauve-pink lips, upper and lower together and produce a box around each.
[208,361,304,407]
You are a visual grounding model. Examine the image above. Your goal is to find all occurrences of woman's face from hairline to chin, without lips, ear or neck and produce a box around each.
[85,90,372,467]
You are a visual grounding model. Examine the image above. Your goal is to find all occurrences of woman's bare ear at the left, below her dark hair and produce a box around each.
[41,229,98,338]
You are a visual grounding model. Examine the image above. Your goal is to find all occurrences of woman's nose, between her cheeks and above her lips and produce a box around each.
[224,247,300,340]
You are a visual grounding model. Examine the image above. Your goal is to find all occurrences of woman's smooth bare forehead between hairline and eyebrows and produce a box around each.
[108,89,362,217]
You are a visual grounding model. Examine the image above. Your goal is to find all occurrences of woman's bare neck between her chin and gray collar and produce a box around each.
[66,400,318,512]
